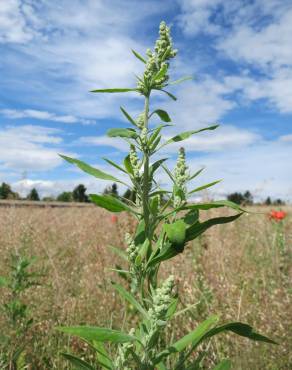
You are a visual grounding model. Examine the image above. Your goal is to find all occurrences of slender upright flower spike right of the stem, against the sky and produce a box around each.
[173,148,189,208]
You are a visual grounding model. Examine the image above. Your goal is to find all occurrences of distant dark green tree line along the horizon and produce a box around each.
[0,182,285,205]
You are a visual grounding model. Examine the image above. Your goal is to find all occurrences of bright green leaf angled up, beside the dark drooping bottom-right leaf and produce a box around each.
[155,315,219,363]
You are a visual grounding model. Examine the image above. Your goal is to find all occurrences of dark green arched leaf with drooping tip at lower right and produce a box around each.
[202,322,278,344]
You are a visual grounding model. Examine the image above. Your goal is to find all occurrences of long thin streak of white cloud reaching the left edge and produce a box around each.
[0,109,95,125]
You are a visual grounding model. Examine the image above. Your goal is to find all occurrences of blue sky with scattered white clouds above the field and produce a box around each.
[0,0,292,201]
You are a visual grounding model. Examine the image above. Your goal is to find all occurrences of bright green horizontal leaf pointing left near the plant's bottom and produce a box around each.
[56,326,137,343]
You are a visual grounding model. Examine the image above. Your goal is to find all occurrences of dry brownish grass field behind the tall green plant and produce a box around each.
[0,207,292,370]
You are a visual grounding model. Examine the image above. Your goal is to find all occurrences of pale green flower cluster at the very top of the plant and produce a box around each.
[137,22,177,95]
